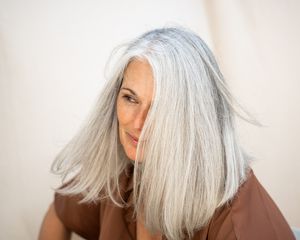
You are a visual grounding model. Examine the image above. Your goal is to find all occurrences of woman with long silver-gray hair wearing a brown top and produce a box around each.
[40,28,294,240]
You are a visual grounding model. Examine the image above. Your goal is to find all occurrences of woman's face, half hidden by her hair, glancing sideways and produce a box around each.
[117,60,153,160]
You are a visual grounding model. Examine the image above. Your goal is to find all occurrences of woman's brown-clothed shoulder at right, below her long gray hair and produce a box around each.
[193,170,295,240]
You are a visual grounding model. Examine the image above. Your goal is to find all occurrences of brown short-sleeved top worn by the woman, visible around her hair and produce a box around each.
[55,169,295,240]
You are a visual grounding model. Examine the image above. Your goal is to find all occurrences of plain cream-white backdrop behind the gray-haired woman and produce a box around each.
[0,0,300,240]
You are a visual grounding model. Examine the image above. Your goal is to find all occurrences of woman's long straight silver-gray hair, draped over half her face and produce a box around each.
[52,27,255,240]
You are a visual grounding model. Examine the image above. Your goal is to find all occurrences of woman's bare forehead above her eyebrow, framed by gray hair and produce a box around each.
[122,60,154,98]
